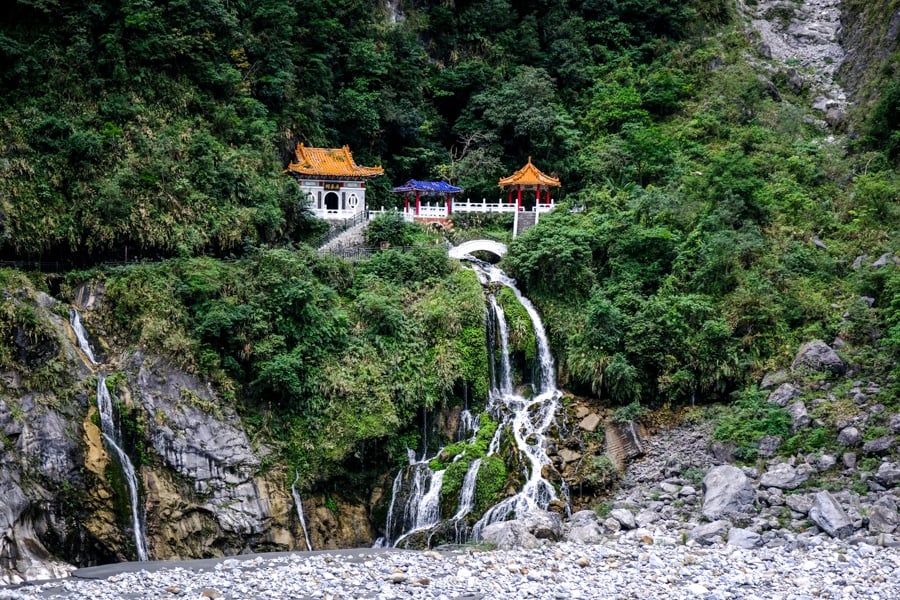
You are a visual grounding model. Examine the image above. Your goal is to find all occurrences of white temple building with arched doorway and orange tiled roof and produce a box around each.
[284,143,384,219]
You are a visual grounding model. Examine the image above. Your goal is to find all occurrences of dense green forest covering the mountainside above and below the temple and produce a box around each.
[0,0,900,492]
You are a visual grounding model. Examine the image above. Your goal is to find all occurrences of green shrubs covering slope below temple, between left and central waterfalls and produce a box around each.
[98,248,486,483]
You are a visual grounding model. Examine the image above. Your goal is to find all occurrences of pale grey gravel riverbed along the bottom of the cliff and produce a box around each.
[0,538,900,600]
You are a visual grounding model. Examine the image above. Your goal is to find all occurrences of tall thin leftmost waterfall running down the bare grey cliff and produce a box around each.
[69,308,149,561]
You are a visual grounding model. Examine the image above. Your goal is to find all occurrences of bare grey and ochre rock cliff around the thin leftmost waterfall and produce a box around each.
[0,286,374,584]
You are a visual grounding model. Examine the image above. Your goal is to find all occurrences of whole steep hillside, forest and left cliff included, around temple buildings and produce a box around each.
[0,0,900,578]
